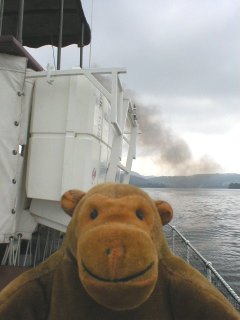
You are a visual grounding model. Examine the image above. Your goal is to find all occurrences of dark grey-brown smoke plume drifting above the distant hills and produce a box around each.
[137,103,220,175]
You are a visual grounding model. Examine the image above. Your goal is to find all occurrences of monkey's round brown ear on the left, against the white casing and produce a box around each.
[60,189,85,217]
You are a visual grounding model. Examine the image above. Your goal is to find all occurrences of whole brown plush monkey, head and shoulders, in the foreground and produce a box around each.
[0,184,240,320]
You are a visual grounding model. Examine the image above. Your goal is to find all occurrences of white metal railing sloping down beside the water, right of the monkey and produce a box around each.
[164,224,240,311]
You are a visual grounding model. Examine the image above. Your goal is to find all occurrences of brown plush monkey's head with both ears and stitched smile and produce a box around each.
[61,184,173,310]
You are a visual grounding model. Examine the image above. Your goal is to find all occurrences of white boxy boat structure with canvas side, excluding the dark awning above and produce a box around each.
[0,54,138,242]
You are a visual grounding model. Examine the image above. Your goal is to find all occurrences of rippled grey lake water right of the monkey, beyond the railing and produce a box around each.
[145,188,240,295]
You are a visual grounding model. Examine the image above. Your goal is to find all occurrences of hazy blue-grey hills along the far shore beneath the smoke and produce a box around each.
[130,173,240,188]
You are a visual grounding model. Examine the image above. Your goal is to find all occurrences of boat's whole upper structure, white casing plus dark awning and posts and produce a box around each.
[0,0,138,284]
